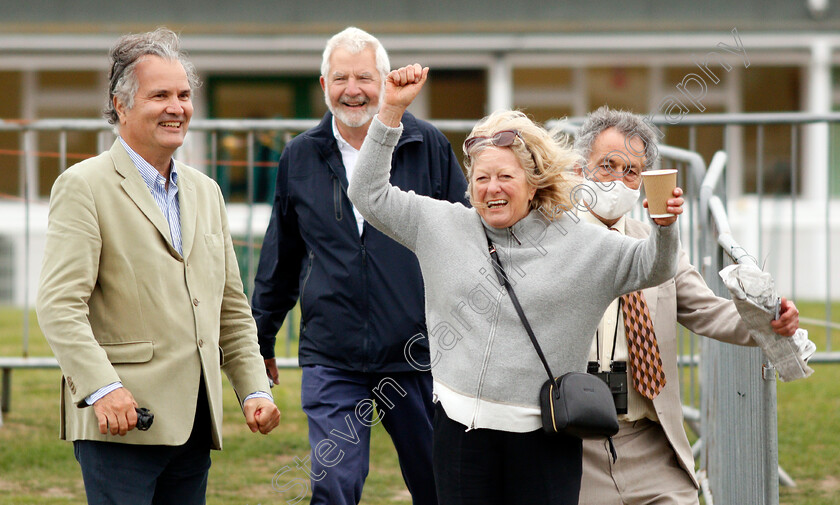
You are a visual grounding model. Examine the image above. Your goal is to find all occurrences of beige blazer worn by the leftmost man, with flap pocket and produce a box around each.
[37,140,268,449]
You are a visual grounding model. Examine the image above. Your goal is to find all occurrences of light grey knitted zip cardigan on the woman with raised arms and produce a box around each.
[349,117,679,432]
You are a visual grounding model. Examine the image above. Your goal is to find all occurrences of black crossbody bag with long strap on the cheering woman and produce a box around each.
[485,231,618,440]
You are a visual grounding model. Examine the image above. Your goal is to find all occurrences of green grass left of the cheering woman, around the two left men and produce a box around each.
[0,308,411,505]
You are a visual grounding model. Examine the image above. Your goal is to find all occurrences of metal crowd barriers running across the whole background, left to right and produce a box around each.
[0,113,840,505]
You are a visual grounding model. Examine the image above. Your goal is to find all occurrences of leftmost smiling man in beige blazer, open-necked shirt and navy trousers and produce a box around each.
[37,29,280,505]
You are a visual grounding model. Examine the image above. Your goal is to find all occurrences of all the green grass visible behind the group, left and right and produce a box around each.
[0,303,840,505]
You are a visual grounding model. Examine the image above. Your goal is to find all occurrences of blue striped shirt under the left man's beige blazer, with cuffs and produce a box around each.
[85,137,272,405]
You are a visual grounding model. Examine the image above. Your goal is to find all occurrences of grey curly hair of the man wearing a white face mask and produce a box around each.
[575,105,659,170]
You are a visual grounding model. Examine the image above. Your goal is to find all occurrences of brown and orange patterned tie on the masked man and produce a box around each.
[621,291,665,400]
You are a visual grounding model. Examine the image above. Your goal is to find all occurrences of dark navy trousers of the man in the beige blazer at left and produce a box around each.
[73,380,211,505]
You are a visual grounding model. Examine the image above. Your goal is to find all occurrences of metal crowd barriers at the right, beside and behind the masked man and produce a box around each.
[565,113,840,505]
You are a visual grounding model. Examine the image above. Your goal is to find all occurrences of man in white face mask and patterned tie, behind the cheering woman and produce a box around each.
[575,107,799,505]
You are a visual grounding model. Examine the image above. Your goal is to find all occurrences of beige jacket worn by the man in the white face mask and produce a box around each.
[625,218,755,486]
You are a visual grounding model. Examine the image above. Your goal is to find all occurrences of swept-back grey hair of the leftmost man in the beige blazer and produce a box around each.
[103,28,201,125]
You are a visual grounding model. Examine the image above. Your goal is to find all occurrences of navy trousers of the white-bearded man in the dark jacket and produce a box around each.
[298,365,437,505]
